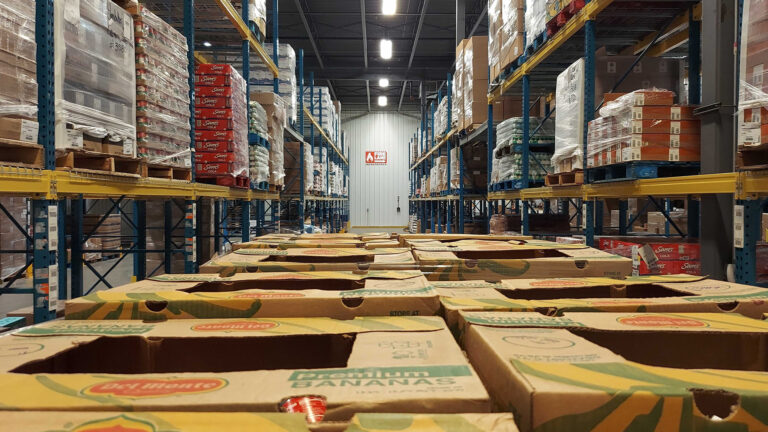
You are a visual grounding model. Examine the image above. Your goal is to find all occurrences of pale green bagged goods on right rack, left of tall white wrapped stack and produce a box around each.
[491,117,554,183]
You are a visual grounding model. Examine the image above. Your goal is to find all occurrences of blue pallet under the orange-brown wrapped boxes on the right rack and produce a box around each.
[587,161,701,183]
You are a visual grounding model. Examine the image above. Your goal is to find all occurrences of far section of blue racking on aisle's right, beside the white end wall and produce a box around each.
[409,74,488,234]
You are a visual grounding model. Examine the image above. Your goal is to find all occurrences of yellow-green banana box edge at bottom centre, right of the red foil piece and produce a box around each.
[346,413,518,432]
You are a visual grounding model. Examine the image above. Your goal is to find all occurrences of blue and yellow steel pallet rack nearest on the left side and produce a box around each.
[0,0,292,322]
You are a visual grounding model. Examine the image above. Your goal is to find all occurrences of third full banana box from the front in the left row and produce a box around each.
[200,248,417,274]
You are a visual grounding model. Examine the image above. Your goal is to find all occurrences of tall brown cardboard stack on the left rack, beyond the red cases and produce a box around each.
[251,92,286,186]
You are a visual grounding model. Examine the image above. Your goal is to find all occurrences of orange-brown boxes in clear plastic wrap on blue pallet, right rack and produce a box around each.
[587,89,701,167]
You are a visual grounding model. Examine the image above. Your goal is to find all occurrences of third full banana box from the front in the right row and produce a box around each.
[413,240,632,281]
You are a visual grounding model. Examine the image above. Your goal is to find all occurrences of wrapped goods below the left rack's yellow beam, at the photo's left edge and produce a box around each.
[0,197,29,281]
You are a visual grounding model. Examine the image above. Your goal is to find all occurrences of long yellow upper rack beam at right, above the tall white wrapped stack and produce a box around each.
[488,0,613,105]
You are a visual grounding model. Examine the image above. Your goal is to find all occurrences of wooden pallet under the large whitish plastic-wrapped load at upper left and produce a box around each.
[56,149,143,178]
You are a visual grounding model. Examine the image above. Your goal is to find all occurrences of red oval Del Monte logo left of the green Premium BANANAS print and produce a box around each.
[82,378,229,399]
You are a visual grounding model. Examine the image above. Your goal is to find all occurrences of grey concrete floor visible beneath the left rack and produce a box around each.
[0,256,133,317]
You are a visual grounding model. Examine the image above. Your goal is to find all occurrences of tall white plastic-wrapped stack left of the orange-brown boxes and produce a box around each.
[552,58,584,172]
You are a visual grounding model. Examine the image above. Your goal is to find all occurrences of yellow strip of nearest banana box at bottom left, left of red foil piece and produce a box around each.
[0,411,309,432]
